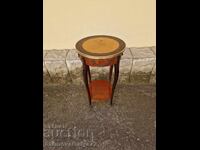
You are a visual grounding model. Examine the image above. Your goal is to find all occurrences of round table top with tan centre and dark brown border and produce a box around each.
[76,35,126,59]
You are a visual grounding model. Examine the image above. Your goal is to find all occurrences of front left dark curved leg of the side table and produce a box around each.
[83,59,91,105]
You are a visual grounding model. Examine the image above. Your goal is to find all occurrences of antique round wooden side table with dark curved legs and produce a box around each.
[76,35,125,105]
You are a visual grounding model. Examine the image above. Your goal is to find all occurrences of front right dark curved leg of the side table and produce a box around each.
[110,56,121,105]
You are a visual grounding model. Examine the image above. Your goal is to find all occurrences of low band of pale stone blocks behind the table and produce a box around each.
[43,46,156,84]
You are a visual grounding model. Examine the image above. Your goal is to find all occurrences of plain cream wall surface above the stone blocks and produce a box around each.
[43,0,156,50]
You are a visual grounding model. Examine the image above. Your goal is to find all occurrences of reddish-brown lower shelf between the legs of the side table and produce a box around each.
[89,80,112,101]
